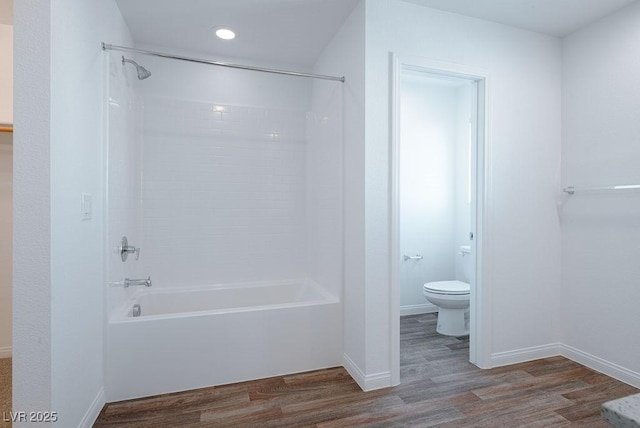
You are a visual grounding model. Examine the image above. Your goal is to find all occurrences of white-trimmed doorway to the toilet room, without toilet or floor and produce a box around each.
[391,57,490,384]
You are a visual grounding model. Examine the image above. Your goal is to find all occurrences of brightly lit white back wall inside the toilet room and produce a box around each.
[399,72,460,314]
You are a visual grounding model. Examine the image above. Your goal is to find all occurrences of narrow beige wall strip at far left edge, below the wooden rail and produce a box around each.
[0,133,13,358]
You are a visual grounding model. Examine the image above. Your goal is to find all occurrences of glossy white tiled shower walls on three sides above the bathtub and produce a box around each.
[108,54,342,311]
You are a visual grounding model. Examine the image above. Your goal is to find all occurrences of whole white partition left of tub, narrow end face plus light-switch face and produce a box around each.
[13,0,128,426]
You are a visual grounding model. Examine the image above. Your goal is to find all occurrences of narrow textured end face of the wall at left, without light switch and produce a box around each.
[12,2,52,427]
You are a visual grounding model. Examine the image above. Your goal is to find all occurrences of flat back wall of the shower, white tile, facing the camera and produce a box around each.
[141,96,308,286]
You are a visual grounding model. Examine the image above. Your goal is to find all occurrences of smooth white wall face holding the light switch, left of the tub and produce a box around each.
[51,0,131,426]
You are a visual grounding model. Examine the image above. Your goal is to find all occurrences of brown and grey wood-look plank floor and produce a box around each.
[94,314,638,428]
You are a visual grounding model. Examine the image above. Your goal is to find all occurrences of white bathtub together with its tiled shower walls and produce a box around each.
[106,53,342,401]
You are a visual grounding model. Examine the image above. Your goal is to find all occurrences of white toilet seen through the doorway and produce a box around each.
[422,245,471,336]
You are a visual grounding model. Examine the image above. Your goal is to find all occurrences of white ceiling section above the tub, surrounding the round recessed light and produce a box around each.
[116,0,358,68]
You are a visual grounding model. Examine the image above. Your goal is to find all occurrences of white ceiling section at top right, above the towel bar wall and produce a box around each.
[403,0,636,37]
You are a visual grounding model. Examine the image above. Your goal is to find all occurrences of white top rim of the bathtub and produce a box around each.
[108,278,340,324]
